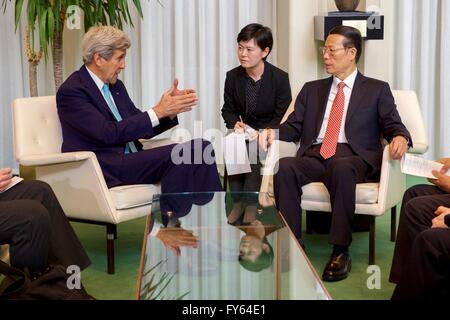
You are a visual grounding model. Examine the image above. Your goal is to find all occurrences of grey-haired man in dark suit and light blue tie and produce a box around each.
[56,26,221,193]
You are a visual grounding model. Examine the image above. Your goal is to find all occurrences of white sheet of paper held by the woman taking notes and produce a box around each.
[224,132,252,176]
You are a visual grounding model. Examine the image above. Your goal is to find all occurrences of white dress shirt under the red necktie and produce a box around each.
[314,69,358,144]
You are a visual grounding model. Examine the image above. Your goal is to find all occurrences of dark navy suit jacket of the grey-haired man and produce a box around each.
[56,66,178,187]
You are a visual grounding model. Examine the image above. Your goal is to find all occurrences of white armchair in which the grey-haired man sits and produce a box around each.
[13,96,178,274]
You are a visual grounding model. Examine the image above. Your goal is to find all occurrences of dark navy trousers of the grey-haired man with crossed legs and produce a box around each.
[120,139,222,193]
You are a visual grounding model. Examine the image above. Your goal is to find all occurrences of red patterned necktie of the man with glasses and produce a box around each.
[320,82,345,160]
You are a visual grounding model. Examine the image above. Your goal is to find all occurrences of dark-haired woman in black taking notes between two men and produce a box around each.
[222,23,292,223]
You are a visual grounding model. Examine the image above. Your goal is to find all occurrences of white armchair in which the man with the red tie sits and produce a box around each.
[260,91,428,265]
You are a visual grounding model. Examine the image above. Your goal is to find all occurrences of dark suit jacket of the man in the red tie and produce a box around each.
[279,73,412,181]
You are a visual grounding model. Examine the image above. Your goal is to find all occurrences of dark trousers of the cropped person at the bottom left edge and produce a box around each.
[0,181,91,272]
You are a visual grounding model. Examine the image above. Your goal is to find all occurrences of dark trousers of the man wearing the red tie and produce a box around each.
[274,144,369,246]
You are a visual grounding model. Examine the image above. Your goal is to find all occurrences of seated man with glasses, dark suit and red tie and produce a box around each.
[260,26,411,281]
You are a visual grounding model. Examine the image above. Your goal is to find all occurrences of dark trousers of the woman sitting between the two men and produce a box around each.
[228,140,262,205]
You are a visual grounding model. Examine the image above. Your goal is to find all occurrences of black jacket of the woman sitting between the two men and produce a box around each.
[222,62,292,129]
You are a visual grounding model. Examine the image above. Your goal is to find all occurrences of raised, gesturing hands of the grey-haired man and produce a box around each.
[153,79,198,119]
